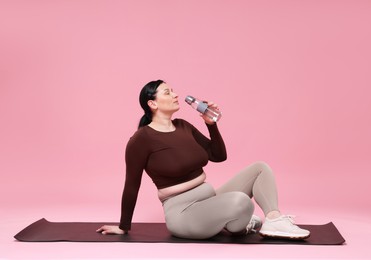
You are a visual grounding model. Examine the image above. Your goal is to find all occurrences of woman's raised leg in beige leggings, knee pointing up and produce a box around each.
[216,162,279,216]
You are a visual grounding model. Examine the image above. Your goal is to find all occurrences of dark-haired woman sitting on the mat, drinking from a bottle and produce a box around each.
[97,80,310,239]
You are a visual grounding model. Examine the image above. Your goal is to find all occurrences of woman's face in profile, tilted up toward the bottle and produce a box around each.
[150,83,179,113]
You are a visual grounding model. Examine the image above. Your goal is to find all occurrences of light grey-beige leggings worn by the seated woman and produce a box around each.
[163,162,278,239]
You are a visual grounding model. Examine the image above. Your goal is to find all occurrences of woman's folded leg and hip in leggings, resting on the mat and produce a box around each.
[164,184,254,239]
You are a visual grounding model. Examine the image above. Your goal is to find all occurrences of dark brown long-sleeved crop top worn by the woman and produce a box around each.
[119,119,227,231]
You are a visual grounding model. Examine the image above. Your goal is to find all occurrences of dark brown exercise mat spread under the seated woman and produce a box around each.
[14,218,345,245]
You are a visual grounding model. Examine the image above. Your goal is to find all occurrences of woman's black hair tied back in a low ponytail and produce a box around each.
[138,79,165,129]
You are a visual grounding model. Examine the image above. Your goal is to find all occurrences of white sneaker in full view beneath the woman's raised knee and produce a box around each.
[259,215,310,239]
